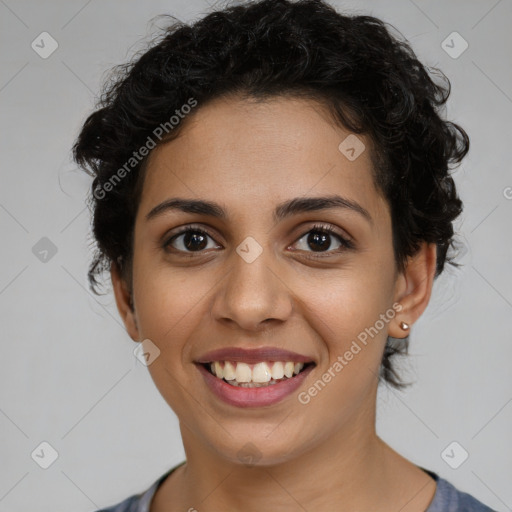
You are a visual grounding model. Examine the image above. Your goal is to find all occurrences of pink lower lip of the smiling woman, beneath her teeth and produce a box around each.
[197,364,314,407]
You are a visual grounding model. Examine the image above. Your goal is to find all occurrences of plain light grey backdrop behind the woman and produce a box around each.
[0,0,512,512]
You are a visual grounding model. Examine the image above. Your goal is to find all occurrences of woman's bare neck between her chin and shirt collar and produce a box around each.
[151,388,435,512]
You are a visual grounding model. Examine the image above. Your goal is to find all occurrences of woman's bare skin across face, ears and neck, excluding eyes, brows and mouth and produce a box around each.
[111,97,436,512]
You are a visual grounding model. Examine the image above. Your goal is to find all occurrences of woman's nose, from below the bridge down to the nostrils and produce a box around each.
[212,244,293,331]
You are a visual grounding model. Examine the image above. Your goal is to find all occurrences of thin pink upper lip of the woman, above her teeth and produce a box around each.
[195,347,314,364]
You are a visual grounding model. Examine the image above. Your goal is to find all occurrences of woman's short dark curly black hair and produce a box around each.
[73,0,469,388]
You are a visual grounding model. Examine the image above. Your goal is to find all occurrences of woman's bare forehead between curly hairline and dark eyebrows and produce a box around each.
[140,98,381,222]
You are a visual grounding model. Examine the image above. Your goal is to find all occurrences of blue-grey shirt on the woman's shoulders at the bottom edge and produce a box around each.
[96,461,496,512]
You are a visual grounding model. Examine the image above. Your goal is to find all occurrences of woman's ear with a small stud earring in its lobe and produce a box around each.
[388,242,437,338]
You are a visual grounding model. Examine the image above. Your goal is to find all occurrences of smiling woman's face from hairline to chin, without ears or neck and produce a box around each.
[112,98,416,464]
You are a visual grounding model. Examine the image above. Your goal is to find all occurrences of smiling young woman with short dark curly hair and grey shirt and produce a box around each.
[74,0,491,512]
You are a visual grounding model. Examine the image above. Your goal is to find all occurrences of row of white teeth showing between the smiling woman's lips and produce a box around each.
[200,361,315,388]
